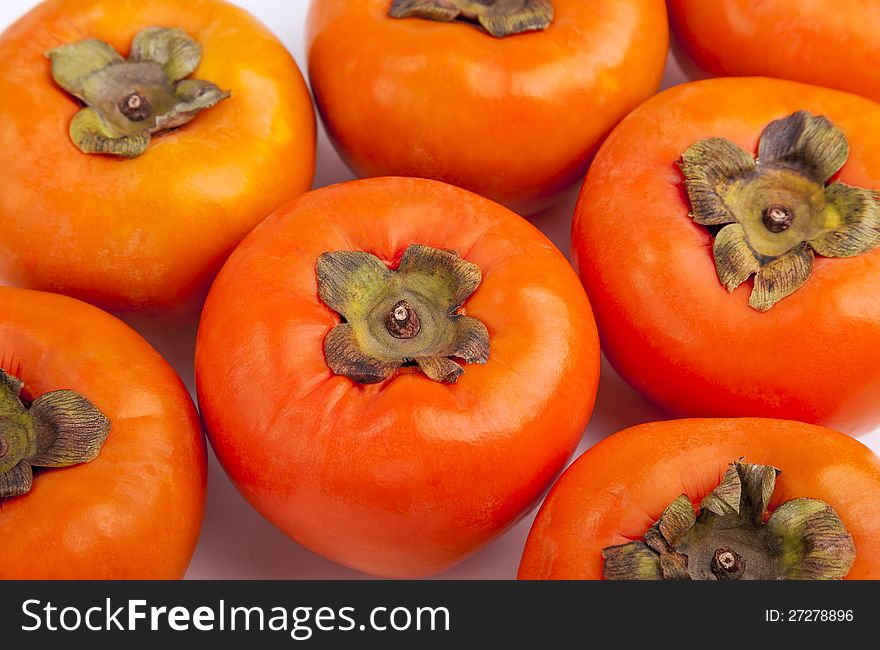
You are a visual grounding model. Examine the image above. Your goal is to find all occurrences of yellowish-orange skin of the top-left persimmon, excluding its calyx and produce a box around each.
[0,0,315,310]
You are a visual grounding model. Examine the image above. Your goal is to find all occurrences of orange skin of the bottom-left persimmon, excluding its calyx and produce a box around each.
[0,287,206,579]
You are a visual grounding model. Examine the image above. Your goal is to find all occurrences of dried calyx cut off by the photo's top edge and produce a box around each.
[388,0,553,38]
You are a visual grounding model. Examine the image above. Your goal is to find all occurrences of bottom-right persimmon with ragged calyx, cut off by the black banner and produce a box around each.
[519,418,880,580]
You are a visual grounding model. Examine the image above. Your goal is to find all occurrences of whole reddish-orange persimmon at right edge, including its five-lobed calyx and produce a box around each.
[572,78,880,433]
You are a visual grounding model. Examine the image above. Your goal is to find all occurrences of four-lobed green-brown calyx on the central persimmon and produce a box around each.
[317,244,489,384]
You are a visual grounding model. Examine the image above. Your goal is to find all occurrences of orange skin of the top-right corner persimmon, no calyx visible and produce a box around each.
[668,0,880,101]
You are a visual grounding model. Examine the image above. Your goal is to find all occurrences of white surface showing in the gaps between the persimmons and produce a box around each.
[0,0,880,579]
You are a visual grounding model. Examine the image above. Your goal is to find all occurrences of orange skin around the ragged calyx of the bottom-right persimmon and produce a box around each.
[518,418,880,580]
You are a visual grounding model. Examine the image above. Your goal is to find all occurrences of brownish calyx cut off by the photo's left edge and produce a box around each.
[0,369,110,498]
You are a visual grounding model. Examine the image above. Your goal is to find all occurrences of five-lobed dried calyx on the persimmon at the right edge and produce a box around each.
[679,111,880,311]
